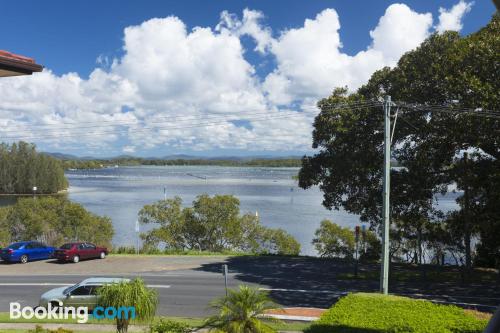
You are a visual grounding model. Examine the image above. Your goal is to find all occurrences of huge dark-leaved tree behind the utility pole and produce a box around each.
[299,13,500,268]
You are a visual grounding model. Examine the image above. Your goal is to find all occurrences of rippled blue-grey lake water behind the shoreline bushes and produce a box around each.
[0,166,456,255]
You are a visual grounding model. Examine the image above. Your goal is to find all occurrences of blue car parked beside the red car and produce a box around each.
[0,241,55,264]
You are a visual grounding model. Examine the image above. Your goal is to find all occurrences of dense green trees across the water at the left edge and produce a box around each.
[0,141,68,194]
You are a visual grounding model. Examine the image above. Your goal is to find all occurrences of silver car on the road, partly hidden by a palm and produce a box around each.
[38,278,130,310]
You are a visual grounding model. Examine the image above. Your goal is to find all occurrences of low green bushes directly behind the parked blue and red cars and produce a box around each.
[0,196,114,246]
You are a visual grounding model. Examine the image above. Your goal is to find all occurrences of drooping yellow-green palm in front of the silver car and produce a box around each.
[98,278,158,333]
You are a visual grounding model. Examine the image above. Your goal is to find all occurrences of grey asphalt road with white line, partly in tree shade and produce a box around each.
[0,257,500,317]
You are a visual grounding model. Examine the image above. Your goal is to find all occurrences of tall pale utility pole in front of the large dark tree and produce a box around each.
[380,96,392,294]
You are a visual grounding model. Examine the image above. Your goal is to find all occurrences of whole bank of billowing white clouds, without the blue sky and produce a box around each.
[0,1,470,154]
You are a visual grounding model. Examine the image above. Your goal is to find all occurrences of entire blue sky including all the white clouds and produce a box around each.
[0,0,495,157]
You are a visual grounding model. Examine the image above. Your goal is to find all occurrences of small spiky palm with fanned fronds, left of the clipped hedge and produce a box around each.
[204,286,275,333]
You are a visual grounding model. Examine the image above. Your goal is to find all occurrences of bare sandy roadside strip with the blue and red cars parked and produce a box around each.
[0,255,228,276]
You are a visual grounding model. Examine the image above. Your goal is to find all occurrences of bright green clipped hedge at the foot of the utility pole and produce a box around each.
[306,293,487,333]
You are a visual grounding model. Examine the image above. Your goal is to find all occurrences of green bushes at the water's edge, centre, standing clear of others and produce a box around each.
[139,194,300,255]
